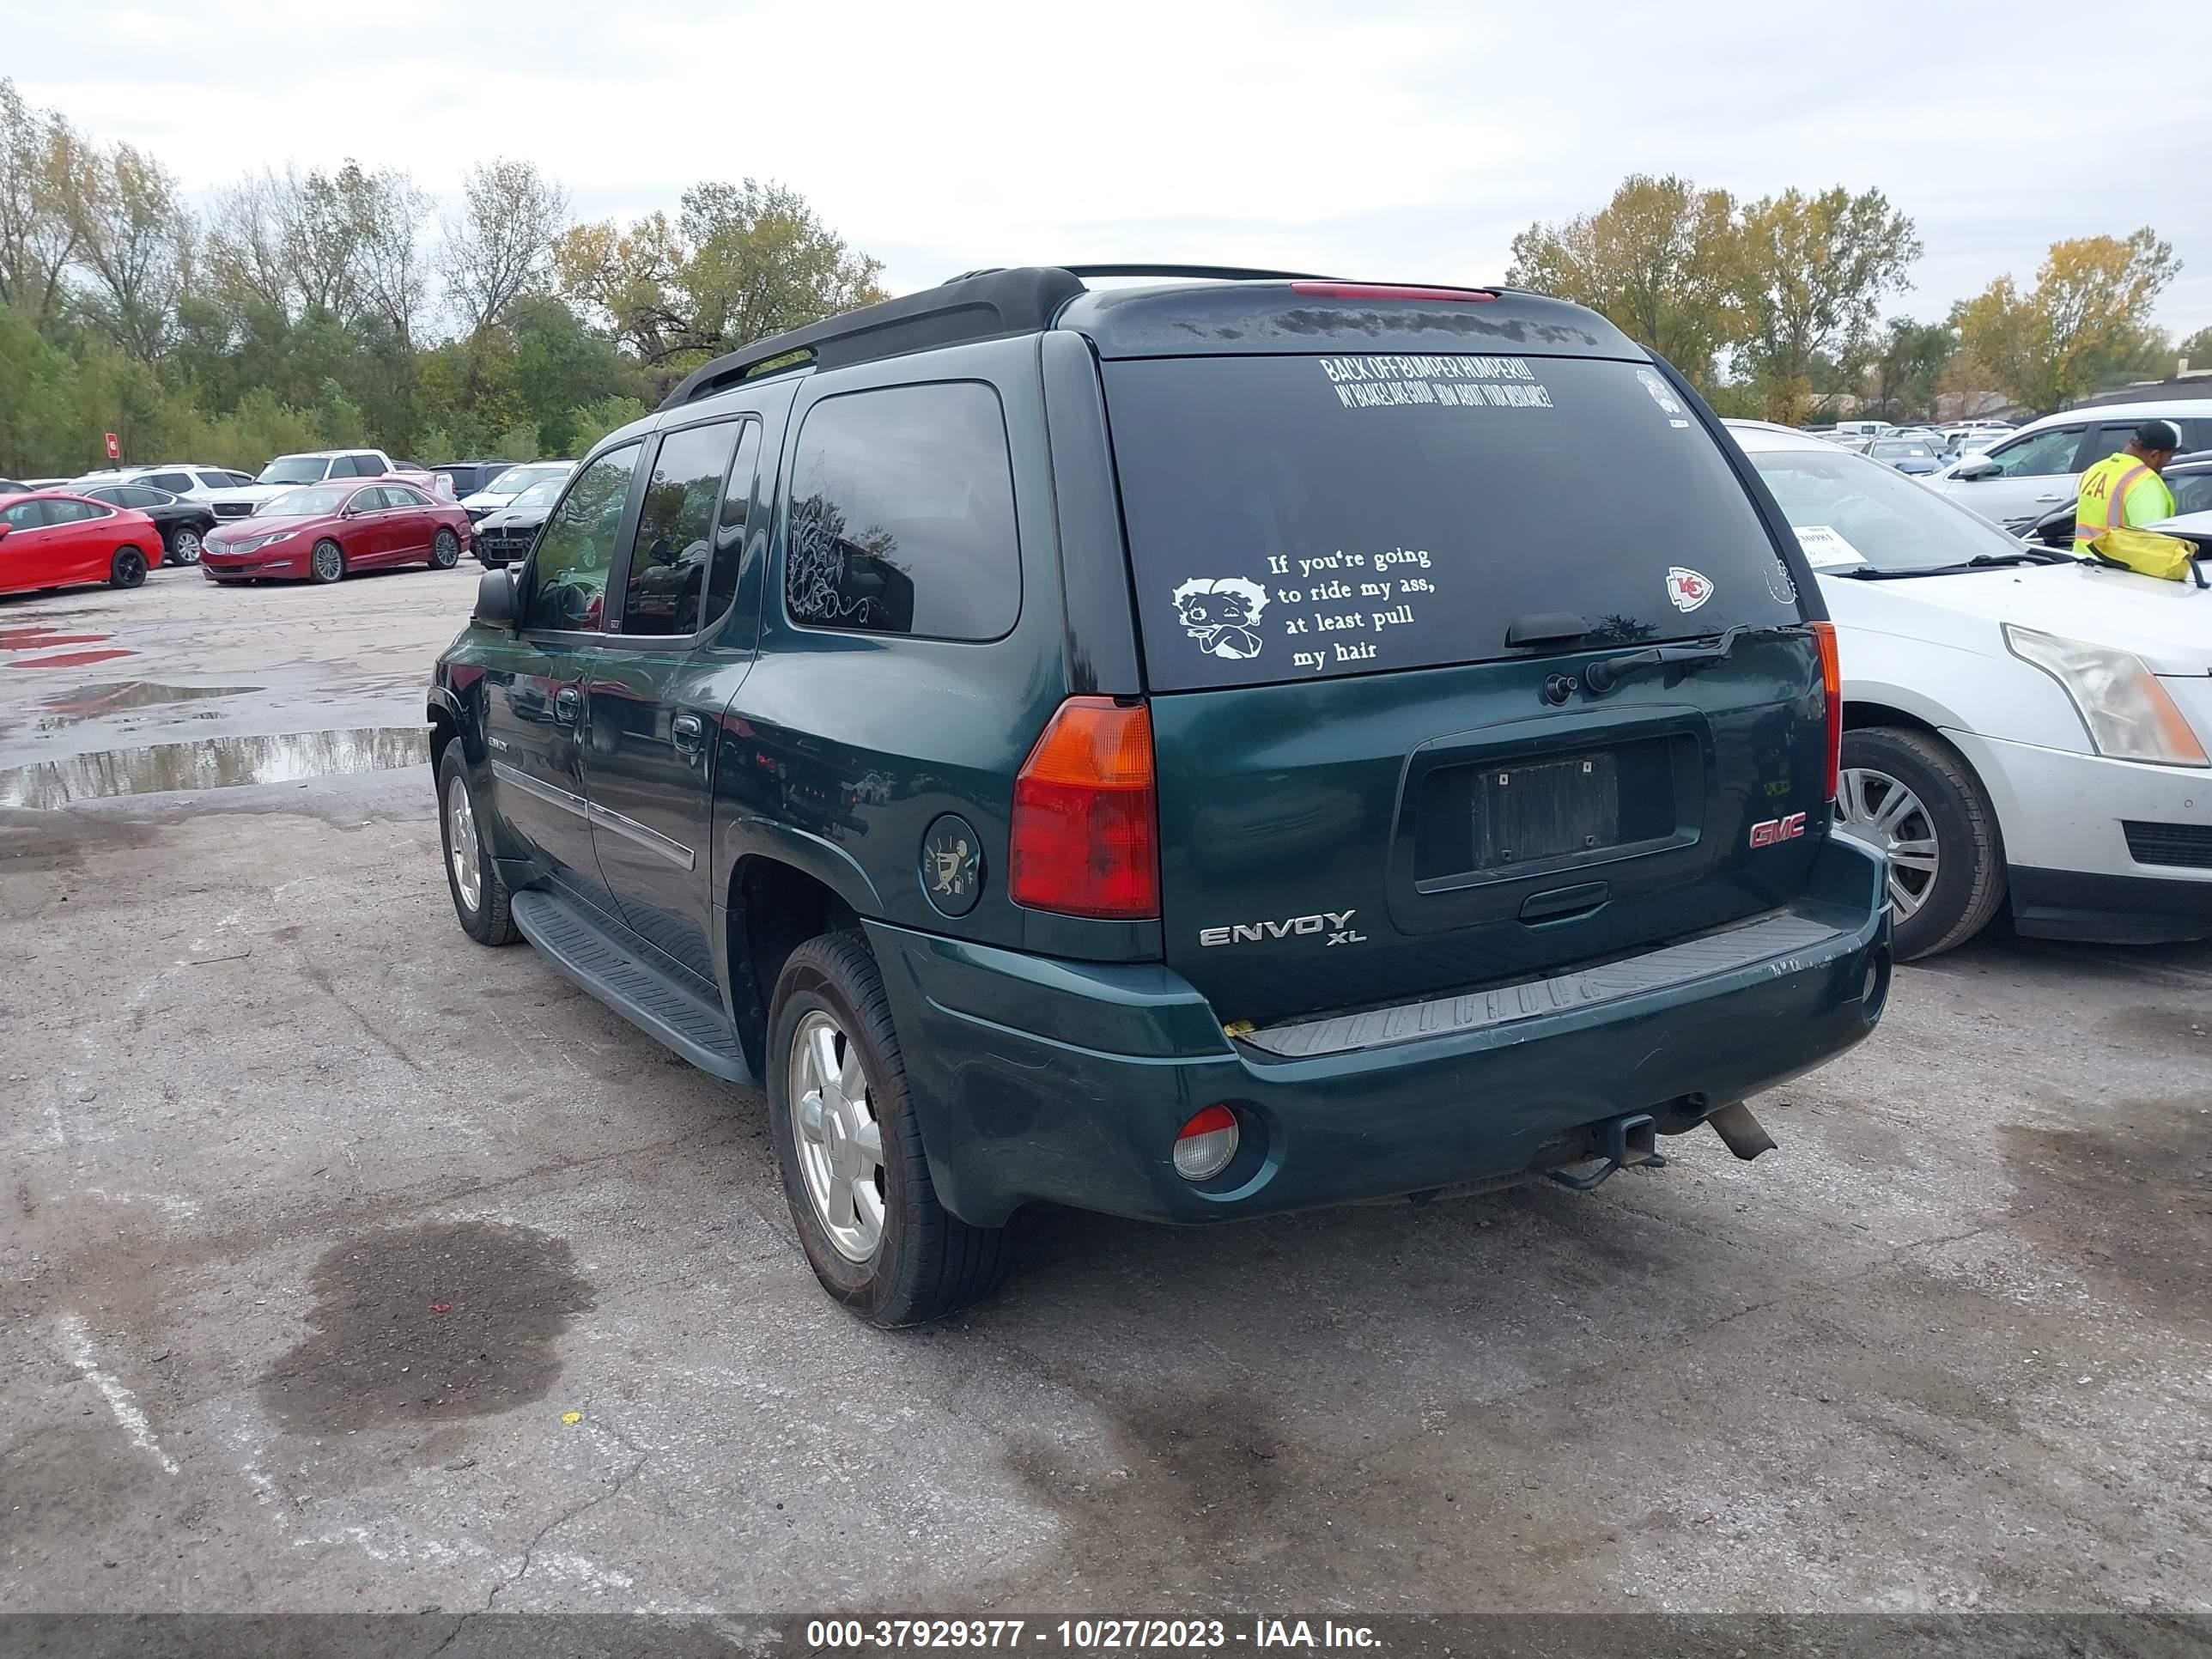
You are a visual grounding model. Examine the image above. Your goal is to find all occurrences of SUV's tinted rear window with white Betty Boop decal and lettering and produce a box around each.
[1103,354,1801,690]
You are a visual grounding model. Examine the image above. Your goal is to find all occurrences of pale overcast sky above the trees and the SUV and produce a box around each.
[17,0,2212,337]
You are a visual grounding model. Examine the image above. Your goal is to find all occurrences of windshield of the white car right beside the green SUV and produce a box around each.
[1752,449,2020,575]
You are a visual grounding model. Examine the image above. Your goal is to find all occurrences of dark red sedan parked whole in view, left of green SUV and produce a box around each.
[199,477,469,581]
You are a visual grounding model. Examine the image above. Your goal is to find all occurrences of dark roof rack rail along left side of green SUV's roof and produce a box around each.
[661,265,1084,410]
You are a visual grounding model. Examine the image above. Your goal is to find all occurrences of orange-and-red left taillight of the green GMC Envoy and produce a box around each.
[1006,696,1159,921]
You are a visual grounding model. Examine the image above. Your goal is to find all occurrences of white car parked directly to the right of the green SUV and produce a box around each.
[1728,420,2212,957]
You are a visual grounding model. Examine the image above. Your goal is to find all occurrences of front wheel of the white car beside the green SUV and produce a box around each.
[1836,726,2004,963]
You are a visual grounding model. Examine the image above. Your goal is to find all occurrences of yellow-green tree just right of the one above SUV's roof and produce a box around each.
[1729,185,1920,425]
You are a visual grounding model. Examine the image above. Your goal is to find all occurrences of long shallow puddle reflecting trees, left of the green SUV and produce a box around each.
[0,726,429,807]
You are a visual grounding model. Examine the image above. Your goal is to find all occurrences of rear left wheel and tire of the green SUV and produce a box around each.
[768,933,1009,1329]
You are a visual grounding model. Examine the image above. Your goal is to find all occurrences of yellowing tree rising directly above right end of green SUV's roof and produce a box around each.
[1506,173,1736,385]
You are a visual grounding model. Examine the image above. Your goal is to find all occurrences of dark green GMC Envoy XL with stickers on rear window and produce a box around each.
[429,265,1889,1325]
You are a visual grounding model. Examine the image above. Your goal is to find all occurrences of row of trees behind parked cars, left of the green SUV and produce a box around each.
[0,80,883,476]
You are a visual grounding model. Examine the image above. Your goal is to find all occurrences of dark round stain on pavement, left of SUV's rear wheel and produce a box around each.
[261,1221,592,1436]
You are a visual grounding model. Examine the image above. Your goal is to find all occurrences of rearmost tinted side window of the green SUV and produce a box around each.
[783,380,1022,639]
